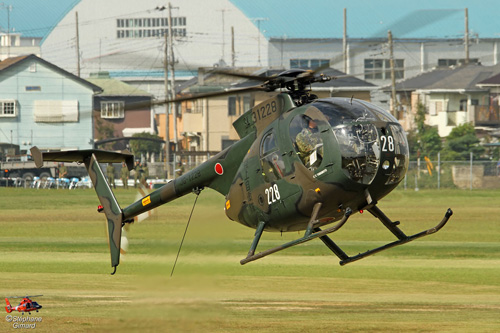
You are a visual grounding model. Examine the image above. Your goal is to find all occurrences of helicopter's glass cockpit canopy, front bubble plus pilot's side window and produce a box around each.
[290,98,409,184]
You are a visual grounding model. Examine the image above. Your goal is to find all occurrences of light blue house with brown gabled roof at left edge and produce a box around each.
[0,54,101,150]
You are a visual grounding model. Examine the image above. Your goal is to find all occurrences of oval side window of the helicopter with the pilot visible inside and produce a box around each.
[290,114,323,170]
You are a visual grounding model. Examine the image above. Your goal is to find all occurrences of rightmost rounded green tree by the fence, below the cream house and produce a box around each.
[443,123,484,161]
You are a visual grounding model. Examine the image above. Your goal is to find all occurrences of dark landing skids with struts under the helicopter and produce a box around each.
[240,203,453,266]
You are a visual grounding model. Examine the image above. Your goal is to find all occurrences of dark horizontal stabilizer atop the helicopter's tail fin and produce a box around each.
[31,147,134,170]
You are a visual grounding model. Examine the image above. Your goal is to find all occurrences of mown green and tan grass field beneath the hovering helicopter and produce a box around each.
[0,188,500,332]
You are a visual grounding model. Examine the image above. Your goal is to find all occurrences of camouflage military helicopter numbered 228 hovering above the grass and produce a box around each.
[31,69,453,274]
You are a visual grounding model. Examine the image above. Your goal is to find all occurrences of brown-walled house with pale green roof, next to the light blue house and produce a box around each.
[88,72,155,150]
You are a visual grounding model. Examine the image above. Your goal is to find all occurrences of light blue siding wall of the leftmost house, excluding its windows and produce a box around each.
[0,59,93,149]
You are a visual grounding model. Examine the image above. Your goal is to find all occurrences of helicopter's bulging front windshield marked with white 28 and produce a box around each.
[311,98,409,184]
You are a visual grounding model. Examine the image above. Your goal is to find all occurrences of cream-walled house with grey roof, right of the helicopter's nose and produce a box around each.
[385,64,500,137]
